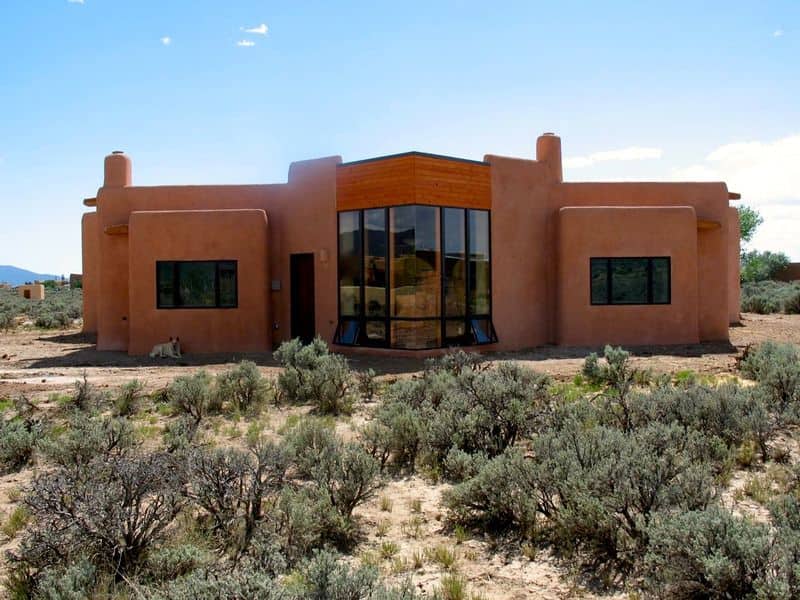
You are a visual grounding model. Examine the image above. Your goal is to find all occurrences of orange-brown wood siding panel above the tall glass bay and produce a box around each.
[336,154,492,210]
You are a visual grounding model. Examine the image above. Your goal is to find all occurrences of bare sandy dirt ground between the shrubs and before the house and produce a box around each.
[0,314,800,600]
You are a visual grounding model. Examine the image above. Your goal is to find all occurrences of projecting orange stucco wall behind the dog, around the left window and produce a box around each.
[128,209,272,354]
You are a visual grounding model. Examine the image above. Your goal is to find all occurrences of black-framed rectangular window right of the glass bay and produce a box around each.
[589,256,672,305]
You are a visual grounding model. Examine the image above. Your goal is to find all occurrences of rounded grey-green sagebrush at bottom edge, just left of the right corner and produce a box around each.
[643,506,771,598]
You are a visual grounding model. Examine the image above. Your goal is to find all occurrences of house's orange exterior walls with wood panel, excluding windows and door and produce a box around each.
[83,135,739,354]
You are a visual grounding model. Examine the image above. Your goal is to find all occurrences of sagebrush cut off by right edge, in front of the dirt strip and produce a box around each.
[739,341,800,421]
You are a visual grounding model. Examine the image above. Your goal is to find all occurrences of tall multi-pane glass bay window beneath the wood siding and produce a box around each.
[335,205,496,349]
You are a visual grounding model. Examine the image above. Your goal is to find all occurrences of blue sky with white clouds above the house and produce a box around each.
[0,0,800,273]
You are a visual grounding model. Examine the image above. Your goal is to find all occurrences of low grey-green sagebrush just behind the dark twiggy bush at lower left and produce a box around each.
[38,413,135,469]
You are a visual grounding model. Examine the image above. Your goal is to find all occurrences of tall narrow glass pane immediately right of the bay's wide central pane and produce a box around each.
[443,208,467,318]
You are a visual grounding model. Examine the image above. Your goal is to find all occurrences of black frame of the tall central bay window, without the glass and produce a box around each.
[333,204,498,352]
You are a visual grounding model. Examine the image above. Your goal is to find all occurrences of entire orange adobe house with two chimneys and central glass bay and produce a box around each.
[83,134,739,355]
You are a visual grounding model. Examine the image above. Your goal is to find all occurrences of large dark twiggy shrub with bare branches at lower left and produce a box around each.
[11,452,186,576]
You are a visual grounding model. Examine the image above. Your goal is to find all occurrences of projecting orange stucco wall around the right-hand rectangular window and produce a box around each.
[556,206,699,346]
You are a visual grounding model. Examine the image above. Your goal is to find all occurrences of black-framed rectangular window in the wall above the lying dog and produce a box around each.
[156,260,238,308]
